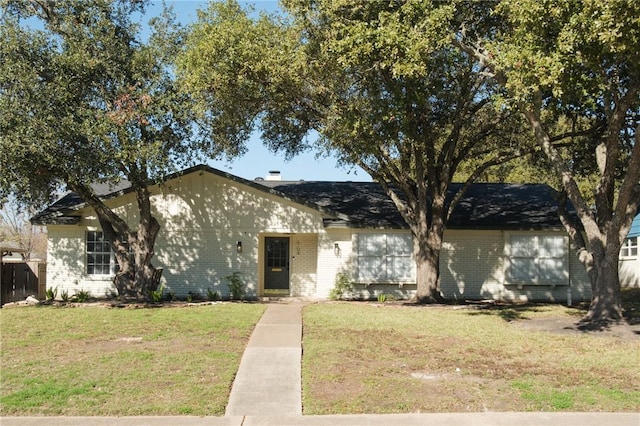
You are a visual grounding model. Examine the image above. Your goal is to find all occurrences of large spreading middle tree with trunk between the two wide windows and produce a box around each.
[179,0,525,302]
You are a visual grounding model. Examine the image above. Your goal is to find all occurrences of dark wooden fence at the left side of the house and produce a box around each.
[0,262,47,305]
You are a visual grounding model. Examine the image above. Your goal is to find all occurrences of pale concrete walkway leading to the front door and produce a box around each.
[225,303,303,417]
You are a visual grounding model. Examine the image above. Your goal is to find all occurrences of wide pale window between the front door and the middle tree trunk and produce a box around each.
[356,234,415,283]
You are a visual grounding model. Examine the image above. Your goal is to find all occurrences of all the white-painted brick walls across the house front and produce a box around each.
[42,168,590,301]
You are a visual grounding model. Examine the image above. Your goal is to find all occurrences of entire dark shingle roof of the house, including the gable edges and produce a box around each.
[31,166,562,229]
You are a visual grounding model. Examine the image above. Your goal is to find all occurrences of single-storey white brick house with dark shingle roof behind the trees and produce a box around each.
[32,166,591,301]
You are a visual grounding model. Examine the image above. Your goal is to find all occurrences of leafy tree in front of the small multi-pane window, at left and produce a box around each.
[0,0,210,298]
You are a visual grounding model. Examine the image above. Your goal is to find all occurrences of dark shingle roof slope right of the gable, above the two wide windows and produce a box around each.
[260,181,562,229]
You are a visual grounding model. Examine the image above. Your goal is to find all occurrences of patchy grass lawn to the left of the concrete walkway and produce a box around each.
[0,304,265,416]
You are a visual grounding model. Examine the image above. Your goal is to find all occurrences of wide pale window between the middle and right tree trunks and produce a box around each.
[507,234,569,285]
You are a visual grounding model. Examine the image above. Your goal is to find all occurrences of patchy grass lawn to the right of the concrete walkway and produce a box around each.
[303,303,640,414]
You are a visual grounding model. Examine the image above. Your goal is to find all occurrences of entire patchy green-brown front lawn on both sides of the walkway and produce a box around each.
[0,299,640,416]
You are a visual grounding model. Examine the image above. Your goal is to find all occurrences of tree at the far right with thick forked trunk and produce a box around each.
[454,0,640,325]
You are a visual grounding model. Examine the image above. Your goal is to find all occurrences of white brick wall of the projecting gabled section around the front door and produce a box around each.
[47,173,324,296]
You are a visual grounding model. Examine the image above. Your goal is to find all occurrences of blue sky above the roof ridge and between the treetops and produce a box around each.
[147,0,371,181]
